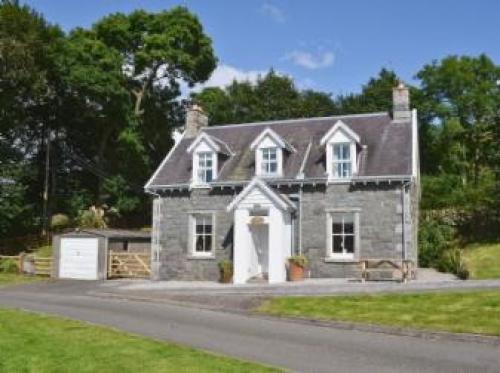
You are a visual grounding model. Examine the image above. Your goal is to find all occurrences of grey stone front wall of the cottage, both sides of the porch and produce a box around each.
[153,183,418,281]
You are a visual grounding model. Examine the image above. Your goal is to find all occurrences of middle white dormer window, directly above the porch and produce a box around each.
[250,128,295,177]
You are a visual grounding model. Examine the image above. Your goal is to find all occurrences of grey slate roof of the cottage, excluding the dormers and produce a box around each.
[147,113,412,189]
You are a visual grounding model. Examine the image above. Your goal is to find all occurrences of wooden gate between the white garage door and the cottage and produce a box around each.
[108,250,151,278]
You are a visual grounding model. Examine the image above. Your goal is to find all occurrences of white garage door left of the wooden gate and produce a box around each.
[59,238,98,280]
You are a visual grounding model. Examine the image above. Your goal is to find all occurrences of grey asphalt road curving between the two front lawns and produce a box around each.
[0,286,500,372]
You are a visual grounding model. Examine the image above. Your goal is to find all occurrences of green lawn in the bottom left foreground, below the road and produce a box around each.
[0,308,278,373]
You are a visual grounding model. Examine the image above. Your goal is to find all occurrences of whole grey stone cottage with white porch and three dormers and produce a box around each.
[145,84,419,283]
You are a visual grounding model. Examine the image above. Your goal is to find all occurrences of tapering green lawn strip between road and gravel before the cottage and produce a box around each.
[257,291,500,336]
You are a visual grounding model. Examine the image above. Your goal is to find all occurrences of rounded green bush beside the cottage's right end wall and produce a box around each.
[418,219,455,268]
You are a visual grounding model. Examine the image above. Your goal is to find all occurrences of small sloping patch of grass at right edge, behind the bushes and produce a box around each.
[464,243,500,280]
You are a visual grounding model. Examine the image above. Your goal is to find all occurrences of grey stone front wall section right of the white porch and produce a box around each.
[302,183,411,277]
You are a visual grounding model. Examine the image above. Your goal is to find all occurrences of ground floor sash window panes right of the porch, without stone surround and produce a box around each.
[328,211,357,259]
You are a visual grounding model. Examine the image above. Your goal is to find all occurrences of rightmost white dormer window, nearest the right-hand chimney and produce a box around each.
[321,120,360,180]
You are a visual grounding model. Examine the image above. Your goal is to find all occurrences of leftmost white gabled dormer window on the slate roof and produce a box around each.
[187,132,233,187]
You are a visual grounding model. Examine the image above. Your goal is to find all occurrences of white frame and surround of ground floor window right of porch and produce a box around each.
[326,209,360,261]
